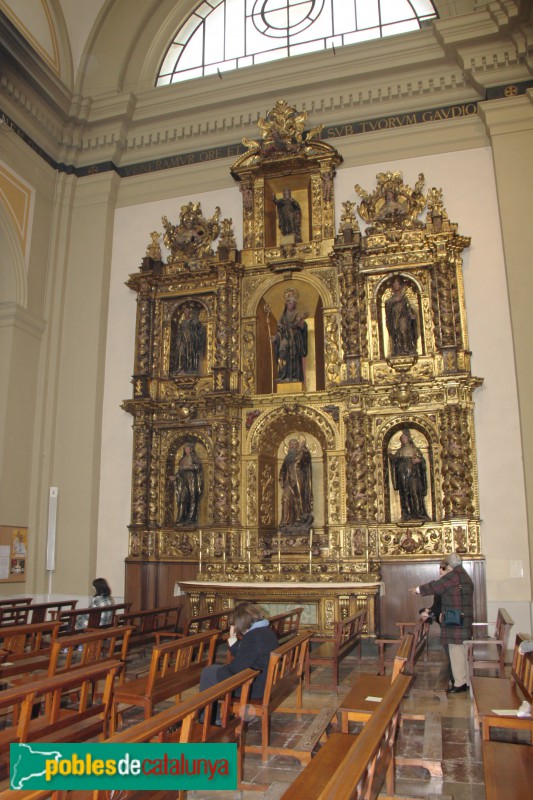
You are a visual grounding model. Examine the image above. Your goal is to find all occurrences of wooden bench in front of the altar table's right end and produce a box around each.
[305,609,366,692]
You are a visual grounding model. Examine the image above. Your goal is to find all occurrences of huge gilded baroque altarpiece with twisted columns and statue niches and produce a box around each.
[124,101,481,620]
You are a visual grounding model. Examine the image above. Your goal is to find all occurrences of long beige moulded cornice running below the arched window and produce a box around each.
[0,1,532,171]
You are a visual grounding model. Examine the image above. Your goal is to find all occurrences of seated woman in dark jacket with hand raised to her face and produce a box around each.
[200,603,279,700]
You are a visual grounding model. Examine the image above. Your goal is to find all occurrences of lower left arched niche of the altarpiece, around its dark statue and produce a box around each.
[162,432,213,530]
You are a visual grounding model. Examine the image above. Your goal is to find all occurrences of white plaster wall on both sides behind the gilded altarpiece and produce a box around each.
[97,145,531,630]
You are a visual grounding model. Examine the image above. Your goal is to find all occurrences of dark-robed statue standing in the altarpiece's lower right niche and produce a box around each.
[389,428,429,522]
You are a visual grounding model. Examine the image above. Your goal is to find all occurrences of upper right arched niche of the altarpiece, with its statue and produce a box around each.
[376,273,425,358]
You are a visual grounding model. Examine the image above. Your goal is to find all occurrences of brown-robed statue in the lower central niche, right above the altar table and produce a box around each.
[279,436,314,533]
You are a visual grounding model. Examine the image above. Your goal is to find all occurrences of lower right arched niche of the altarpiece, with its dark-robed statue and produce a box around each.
[382,421,436,524]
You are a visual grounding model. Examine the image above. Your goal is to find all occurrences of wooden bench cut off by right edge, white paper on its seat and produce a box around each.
[470,633,533,740]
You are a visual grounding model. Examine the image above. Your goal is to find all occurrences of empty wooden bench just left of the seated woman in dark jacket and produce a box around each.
[112,630,219,733]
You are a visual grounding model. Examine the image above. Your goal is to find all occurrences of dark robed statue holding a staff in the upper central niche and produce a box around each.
[272,289,307,383]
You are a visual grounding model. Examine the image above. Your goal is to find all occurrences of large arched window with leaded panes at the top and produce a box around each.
[156,0,437,86]
